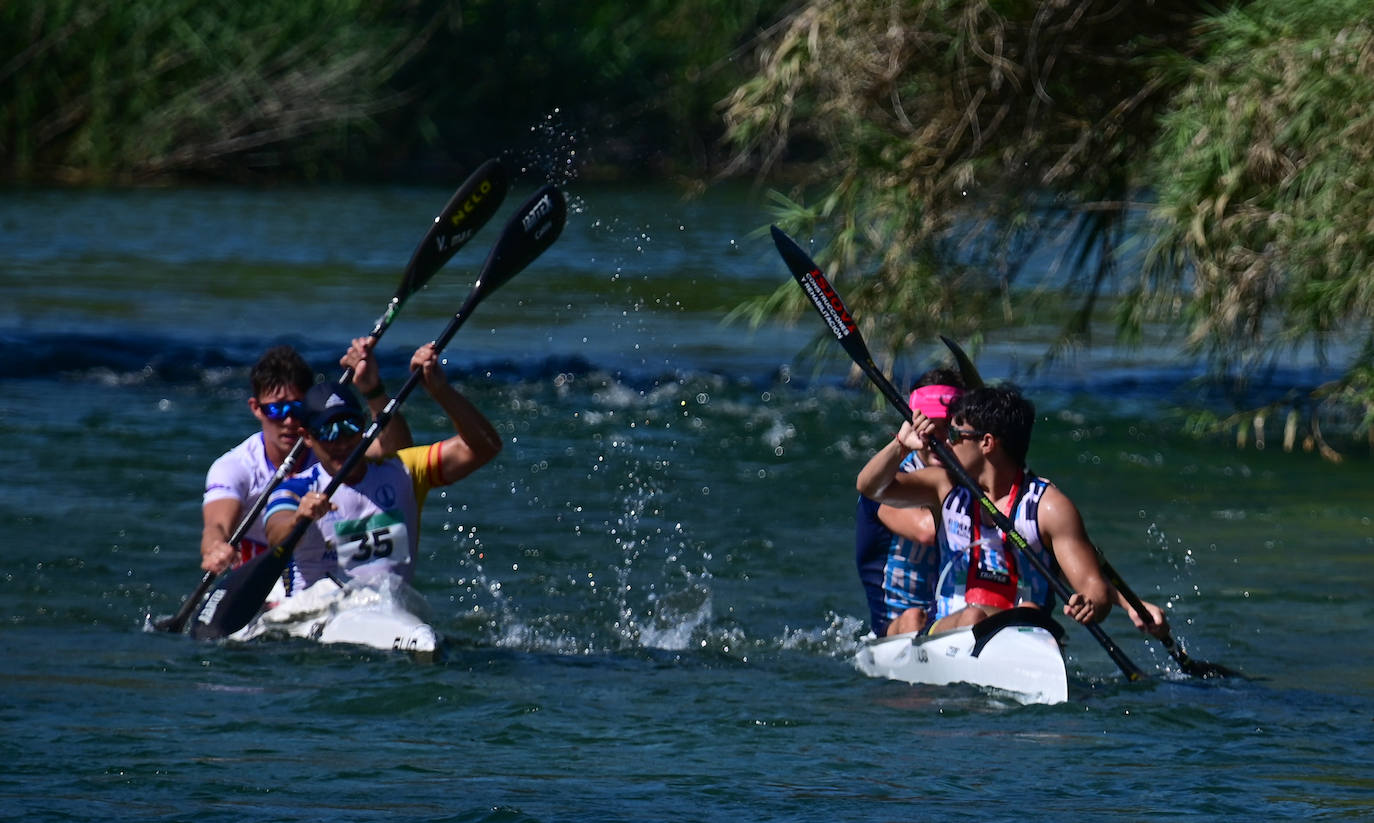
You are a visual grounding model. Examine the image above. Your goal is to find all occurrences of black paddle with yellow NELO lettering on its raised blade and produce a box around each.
[153,159,506,632]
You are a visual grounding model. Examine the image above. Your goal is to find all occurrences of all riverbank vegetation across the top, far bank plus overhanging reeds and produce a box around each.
[0,0,1374,455]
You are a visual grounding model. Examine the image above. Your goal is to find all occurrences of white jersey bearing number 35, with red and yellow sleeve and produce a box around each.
[267,442,447,596]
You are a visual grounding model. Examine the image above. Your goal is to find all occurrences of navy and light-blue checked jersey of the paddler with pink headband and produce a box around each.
[855,452,941,638]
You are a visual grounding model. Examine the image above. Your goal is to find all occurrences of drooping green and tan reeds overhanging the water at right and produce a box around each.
[727,0,1374,455]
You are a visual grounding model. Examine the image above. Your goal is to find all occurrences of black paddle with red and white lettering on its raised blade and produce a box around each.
[772,225,1145,680]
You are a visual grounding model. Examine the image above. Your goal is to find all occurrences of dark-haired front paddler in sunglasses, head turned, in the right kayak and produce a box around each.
[857,385,1168,636]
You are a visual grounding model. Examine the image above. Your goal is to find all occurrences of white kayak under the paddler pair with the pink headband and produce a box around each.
[855,607,1069,703]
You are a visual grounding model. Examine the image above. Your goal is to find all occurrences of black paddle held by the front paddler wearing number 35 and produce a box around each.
[191,185,567,640]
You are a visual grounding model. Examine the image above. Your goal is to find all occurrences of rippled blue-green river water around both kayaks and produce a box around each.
[0,181,1374,822]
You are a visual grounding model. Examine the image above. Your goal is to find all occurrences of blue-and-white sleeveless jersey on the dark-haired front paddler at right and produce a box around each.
[936,471,1058,620]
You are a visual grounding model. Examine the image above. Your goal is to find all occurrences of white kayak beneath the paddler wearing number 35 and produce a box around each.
[229,577,440,657]
